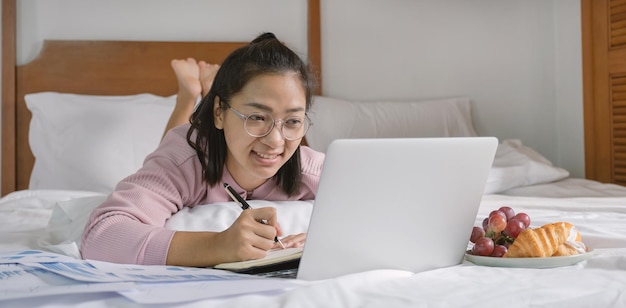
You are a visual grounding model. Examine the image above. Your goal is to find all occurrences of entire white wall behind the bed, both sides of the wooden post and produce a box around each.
[4,0,584,177]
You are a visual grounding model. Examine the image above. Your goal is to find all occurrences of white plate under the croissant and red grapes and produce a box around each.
[465,250,593,268]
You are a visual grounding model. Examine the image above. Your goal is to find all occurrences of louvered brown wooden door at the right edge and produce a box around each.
[581,0,626,185]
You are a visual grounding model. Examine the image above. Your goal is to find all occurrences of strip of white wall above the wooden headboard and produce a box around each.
[17,0,307,64]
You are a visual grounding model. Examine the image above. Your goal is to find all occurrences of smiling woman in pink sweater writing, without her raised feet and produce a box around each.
[81,33,324,267]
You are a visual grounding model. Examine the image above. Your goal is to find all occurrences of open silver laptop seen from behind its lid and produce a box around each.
[296,137,498,280]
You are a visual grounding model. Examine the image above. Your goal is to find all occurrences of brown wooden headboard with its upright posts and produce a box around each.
[1,0,321,196]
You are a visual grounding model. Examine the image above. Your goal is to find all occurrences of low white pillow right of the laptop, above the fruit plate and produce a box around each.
[485,139,569,194]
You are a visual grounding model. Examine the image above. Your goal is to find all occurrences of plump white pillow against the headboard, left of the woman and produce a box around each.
[25,92,176,193]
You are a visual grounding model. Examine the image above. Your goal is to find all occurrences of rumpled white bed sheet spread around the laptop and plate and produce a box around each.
[0,186,626,307]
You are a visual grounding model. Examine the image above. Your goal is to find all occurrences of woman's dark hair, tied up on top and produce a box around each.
[187,33,317,196]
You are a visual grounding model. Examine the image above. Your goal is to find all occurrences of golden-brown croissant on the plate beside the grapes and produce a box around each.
[503,222,584,258]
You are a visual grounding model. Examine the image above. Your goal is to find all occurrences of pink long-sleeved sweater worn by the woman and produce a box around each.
[81,124,324,265]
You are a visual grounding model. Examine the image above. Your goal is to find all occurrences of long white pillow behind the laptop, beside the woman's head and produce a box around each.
[306,96,476,152]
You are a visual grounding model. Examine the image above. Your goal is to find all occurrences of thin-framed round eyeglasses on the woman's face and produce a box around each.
[224,102,313,140]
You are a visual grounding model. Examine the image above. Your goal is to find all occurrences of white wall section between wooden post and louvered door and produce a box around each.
[322,0,584,176]
